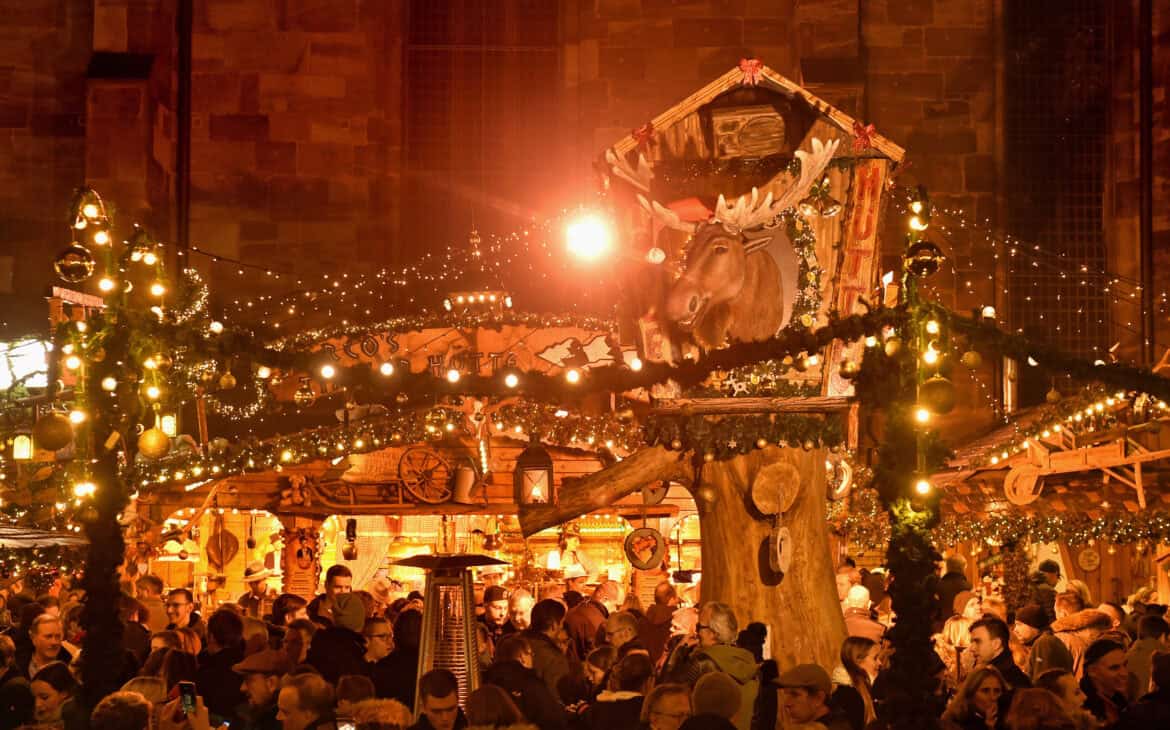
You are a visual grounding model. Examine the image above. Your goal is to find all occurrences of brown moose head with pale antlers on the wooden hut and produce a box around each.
[606,139,838,347]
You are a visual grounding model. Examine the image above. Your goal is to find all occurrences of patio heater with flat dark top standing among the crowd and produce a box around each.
[394,553,508,716]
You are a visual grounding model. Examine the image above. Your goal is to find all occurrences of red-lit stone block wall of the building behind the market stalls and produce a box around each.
[0,0,1170,428]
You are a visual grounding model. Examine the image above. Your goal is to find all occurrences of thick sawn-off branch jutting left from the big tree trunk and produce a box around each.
[519,446,694,537]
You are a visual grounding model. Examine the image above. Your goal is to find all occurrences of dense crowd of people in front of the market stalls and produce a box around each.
[0,558,1170,730]
